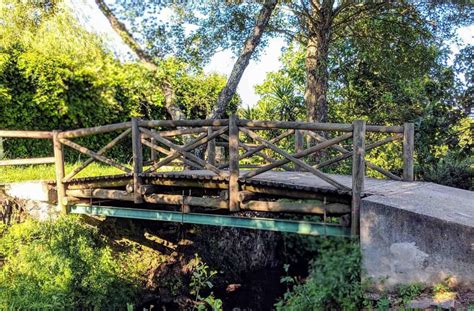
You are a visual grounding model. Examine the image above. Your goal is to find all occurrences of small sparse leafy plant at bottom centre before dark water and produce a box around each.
[189,254,222,311]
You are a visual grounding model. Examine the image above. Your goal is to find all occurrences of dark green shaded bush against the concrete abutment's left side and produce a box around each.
[275,239,364,310]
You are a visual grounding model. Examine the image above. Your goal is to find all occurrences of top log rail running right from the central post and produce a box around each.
[239,119,403,133]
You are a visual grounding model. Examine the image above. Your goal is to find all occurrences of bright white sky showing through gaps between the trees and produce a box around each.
[67,0,474,107]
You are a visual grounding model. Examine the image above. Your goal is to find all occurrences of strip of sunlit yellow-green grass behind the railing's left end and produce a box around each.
[0,163,123,183]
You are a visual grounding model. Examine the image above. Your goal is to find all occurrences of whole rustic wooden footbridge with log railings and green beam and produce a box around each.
[0,115,414,236]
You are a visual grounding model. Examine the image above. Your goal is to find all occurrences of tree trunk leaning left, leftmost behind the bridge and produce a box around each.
[95,0,185,120]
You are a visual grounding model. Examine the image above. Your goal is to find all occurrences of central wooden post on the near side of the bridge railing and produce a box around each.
[229,114,240,212]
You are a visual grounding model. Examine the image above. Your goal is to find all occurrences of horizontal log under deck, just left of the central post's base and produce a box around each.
[144,194,228,209]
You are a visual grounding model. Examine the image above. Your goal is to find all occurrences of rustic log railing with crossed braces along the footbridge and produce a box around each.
[0,115,414,234]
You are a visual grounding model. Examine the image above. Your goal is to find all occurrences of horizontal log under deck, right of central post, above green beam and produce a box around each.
[240,201,351,216]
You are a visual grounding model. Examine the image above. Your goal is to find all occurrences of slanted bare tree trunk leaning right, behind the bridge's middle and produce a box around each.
[211,0,277,119]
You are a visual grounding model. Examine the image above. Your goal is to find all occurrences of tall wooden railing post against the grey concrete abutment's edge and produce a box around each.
[351,120,365,236]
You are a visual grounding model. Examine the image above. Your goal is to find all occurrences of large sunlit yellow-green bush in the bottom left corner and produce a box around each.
[0,216,136,309]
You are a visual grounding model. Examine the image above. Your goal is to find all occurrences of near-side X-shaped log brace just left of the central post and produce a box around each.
[140,128,226,175]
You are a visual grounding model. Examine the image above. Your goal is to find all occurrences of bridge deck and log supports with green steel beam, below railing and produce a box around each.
[54,170,407,236]
